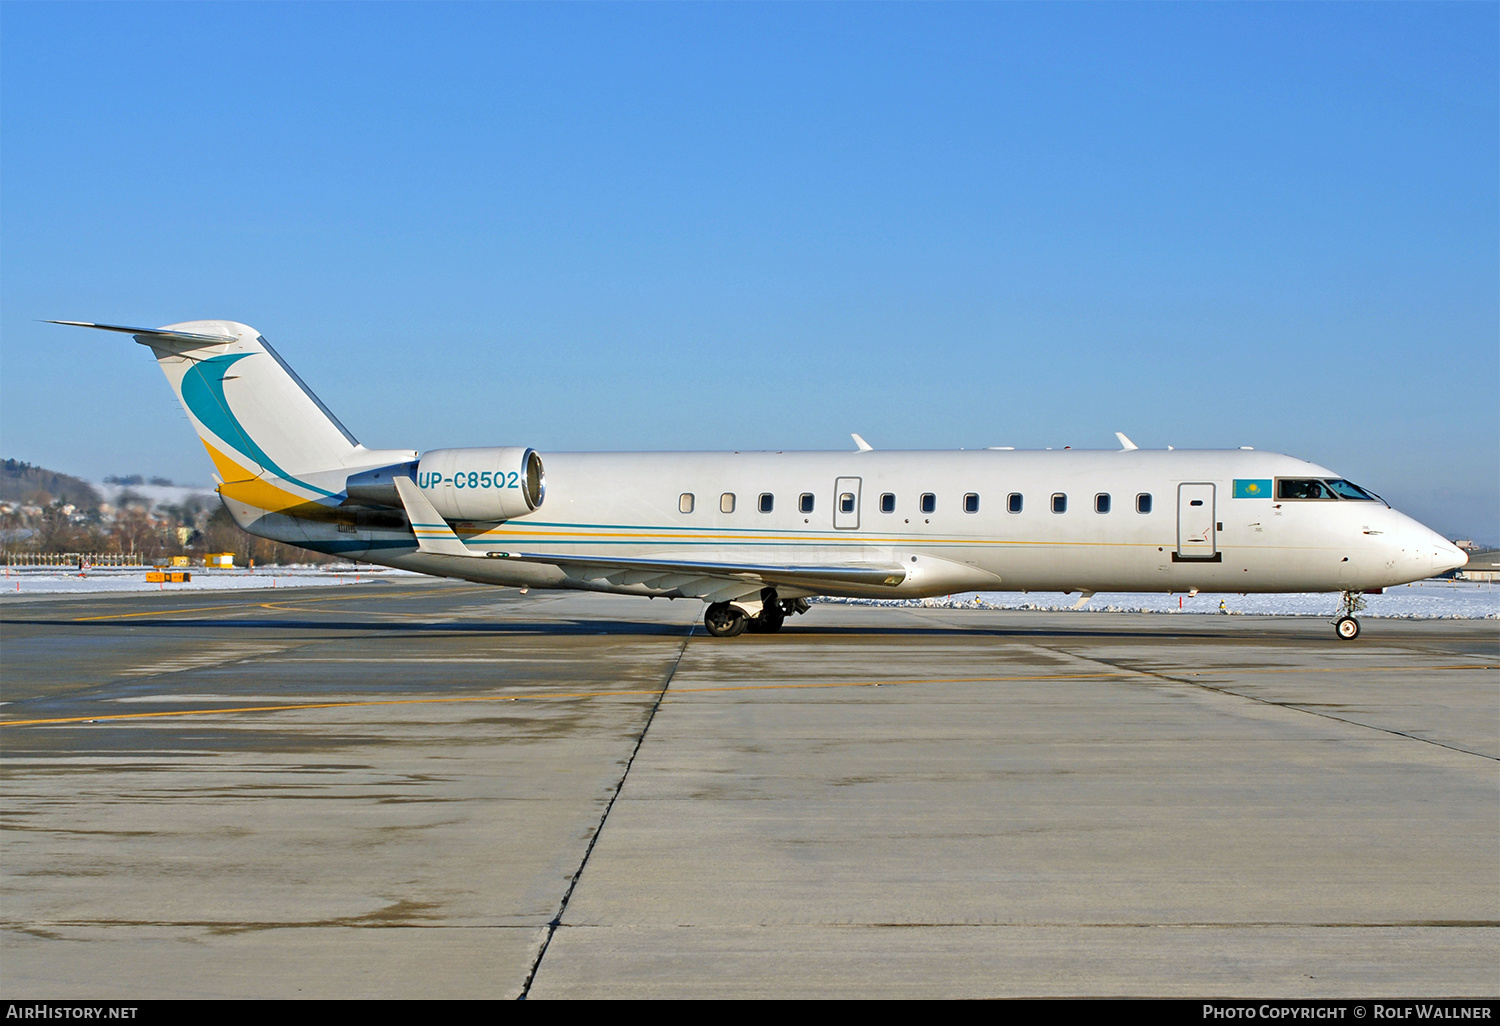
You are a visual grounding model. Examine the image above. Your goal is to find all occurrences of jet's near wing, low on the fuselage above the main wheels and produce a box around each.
[486,552,906,602]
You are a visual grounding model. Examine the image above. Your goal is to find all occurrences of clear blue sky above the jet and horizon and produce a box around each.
[0,2,1500,542]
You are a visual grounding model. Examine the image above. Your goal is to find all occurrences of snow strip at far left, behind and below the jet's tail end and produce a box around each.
[0,563,423,596]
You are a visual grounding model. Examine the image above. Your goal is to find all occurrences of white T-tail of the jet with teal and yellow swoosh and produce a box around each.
[54,321,410,510]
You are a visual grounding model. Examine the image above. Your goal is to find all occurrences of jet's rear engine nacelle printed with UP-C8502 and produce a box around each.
[417,449,548,521]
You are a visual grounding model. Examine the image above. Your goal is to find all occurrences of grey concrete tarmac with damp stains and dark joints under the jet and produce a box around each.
[0,581,1500,999]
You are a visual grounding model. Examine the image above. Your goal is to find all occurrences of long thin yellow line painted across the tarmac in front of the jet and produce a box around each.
[0,665,1496,728]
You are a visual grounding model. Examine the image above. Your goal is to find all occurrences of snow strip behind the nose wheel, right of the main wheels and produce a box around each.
[824,581,1500,620]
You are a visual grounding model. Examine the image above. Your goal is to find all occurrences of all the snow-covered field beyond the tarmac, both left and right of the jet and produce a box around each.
[0,564,1500,620]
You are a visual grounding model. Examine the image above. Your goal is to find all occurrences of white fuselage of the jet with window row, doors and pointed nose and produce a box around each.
[243,449,1454,597]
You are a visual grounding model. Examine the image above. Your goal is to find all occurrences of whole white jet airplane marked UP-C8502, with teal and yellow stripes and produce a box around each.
[54,321,1467,639]
